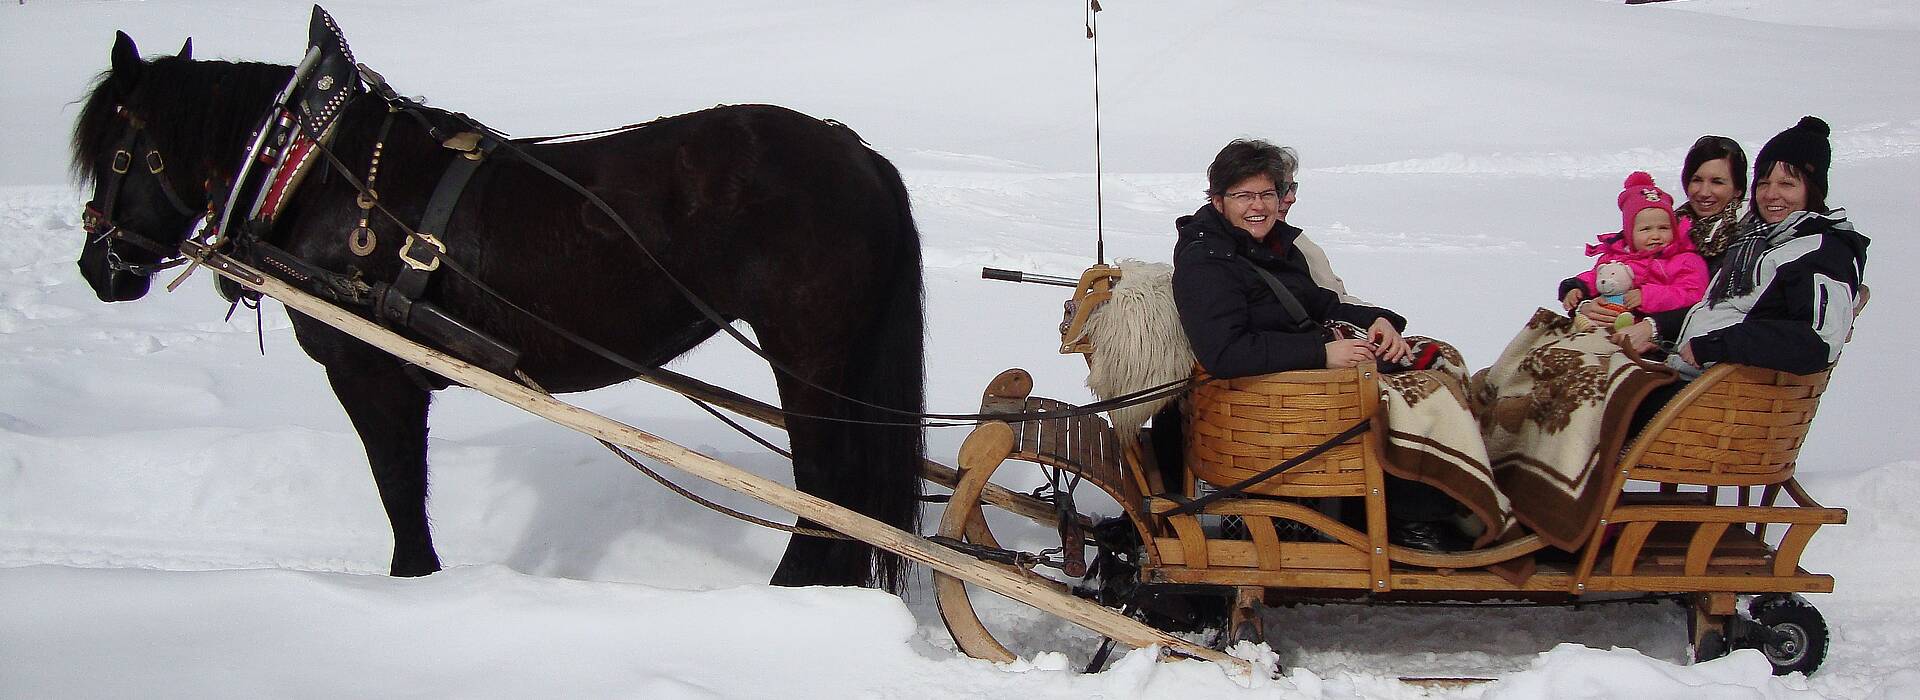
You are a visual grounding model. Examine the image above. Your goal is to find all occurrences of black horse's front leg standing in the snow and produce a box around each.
[326,362,440,575]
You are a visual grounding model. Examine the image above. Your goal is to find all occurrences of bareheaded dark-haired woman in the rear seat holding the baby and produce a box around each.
[1559,134,1747,343]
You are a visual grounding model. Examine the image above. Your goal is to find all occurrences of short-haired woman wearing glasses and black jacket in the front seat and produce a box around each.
[1173,140,1409,378]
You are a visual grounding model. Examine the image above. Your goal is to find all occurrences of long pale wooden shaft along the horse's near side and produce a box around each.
[194,255,1250,671]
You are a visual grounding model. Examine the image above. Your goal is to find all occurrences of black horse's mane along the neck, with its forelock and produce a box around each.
[69,56,294,182]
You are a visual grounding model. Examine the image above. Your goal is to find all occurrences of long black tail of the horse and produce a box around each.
[849,150,927,593]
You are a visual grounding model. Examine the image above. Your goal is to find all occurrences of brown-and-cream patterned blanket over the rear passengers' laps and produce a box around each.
[1469,309,1674,550]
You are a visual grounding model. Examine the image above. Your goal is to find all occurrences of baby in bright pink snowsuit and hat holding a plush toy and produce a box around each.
[1561,171,1707,313]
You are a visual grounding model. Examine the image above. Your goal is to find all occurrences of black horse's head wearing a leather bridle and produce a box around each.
[73,33,207,301]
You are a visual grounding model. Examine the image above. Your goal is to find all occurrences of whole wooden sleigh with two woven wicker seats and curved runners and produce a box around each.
[935,260,1847,673]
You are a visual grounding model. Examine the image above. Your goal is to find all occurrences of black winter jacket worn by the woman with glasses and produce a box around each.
[1173,205,1407,378]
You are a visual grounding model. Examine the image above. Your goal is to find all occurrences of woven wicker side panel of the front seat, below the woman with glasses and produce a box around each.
[1187,370,1379,495]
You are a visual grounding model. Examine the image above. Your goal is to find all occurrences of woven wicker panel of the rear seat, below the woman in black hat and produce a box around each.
[1632,366,1832,483]
